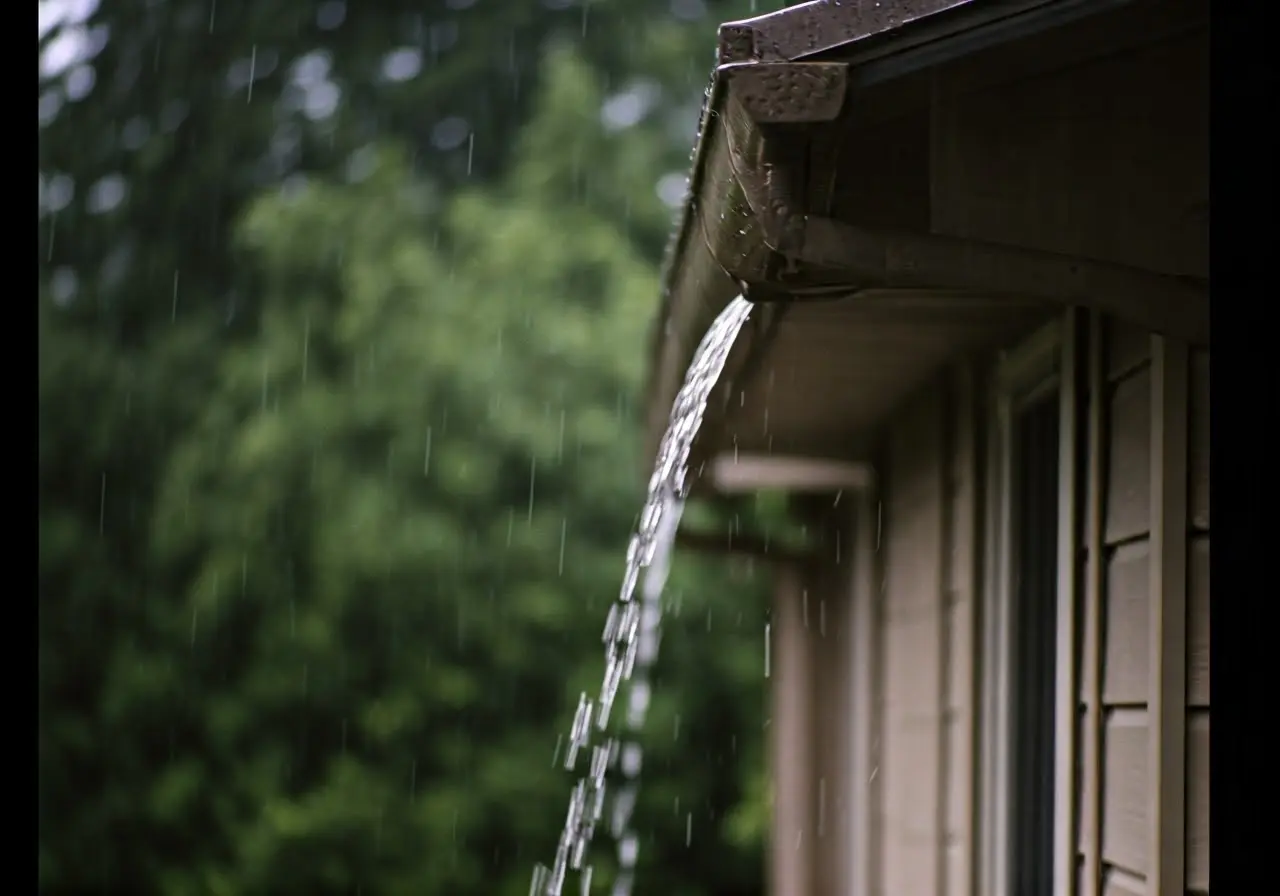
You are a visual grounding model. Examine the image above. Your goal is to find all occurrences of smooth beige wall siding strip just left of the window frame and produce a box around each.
[876,370,978,896]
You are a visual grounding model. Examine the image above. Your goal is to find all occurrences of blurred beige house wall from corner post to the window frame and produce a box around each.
[769,367,980,896]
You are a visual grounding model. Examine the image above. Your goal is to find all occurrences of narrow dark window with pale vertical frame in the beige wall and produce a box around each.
[983,323,1061,896]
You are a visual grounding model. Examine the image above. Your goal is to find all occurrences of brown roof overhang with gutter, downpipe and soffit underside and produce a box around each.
[646,0,1208,486]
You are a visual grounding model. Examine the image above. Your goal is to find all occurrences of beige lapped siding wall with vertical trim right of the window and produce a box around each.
[1076,321,1210,896]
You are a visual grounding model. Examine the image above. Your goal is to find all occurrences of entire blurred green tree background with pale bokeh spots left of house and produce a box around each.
[38,0,783,896]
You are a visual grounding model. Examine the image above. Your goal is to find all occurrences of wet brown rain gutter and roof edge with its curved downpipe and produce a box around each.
[645,0,1208,476]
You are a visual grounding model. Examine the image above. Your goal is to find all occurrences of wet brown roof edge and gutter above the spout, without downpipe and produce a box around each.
[644,0,1157,476]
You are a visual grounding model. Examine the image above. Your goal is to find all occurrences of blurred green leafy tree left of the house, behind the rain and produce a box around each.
[38,6,763,893]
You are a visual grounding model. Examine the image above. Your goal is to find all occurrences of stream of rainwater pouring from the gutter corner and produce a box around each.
[529,297,751,896]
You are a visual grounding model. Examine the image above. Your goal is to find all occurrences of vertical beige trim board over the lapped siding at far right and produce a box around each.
[1147,337,1190,893]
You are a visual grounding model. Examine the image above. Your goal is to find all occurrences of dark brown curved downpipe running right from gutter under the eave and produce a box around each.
[797,215,1210,346]
